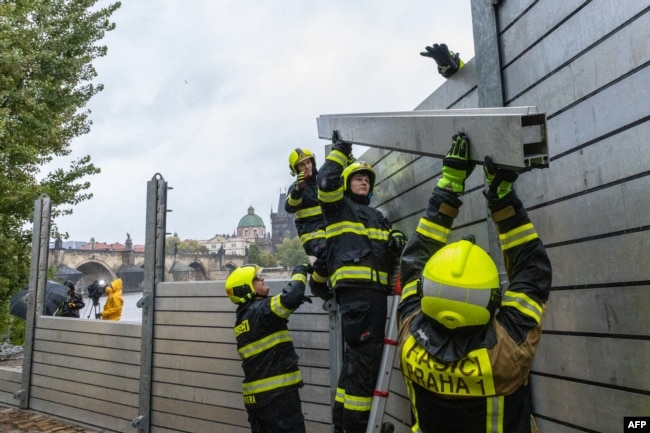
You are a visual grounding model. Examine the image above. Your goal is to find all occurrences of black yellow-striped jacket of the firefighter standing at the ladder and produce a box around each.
[318,144,393,293]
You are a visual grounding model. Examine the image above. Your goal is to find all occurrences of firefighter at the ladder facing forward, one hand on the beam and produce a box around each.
[318,131,405,433]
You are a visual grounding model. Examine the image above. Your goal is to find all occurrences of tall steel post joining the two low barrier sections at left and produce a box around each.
[131,174,168,433]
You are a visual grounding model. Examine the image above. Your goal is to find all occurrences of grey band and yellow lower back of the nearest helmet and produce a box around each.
[421,279,496,329]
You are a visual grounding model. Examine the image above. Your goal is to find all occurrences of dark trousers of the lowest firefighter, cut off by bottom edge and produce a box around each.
[246,389,306,433]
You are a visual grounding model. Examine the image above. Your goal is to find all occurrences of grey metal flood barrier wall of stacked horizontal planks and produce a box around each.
[0,0,650,433]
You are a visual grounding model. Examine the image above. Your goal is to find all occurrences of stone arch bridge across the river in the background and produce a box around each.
[49,248,246,292]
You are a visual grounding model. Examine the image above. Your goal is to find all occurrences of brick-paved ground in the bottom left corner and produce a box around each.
[0,405,103,433]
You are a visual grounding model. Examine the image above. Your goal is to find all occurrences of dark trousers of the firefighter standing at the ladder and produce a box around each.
[332,288,387,433]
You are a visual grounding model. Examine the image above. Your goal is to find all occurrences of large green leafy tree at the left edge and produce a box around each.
[0,0,121,338]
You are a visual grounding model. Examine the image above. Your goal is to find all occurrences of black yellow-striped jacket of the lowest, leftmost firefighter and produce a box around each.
[234,274,306,406]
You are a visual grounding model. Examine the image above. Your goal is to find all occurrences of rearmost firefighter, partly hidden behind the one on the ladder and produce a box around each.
[284,148,331,300]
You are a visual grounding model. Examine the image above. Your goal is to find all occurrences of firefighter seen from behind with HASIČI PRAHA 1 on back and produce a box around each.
[399,134,551,433]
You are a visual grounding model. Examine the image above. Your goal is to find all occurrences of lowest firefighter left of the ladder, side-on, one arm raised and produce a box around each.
[225,265,311,433]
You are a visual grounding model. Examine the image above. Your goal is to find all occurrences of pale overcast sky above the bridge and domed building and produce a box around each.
[56,0,474,244]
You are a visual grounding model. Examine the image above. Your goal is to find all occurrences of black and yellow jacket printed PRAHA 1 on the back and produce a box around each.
[399,188,551,433]
